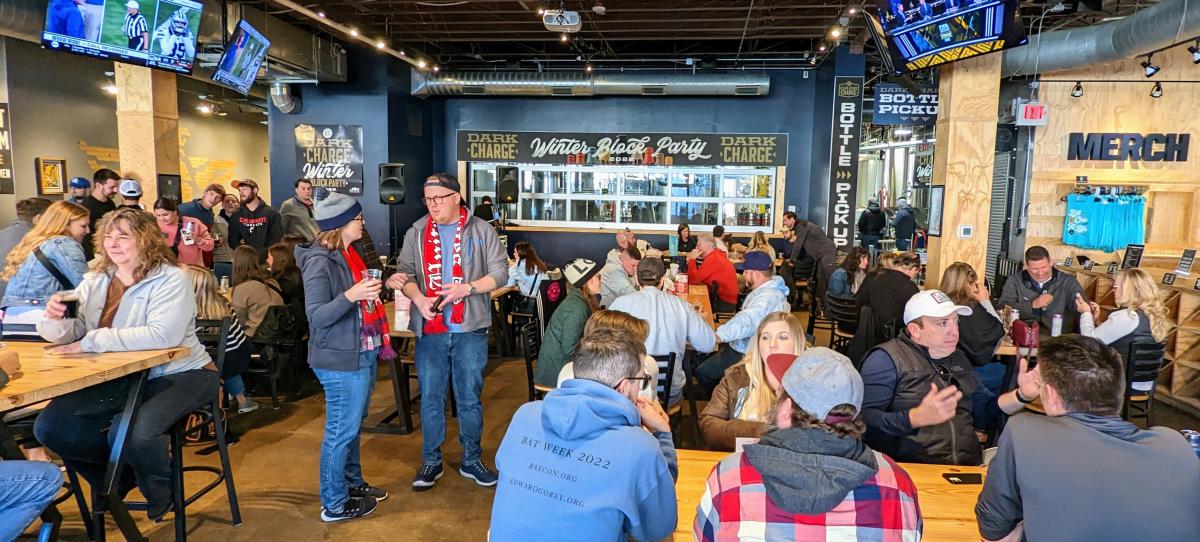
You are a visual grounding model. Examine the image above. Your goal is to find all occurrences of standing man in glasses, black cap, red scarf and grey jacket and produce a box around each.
[389,173,509,492]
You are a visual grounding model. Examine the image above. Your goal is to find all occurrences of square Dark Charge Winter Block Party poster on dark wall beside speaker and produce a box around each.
[295,125,362,195]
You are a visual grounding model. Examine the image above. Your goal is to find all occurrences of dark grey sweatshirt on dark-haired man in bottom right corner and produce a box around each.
[976,412,1200,542]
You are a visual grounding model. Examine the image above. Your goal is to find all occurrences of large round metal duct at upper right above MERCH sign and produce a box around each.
[1002,0,1200,77]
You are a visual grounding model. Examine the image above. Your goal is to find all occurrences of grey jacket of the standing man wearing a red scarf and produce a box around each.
[396,215,509,337]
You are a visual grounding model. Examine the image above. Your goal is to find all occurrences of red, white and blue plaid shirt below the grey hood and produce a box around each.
[692,452,922,542]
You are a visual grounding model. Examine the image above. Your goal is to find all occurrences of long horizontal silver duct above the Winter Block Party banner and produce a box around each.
[412,71,770,98]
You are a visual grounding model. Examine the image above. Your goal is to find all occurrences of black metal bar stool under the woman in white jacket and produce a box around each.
[127,316,241,542]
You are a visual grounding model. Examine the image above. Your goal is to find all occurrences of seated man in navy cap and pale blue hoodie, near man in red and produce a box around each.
[696,252,792,392]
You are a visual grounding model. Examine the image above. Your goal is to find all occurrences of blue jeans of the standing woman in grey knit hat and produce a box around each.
[312,349,379,512]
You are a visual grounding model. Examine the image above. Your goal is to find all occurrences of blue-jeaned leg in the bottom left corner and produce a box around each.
[0,460,62,540]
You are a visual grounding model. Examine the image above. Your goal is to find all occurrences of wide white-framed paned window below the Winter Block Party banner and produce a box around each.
[469,163,775,231]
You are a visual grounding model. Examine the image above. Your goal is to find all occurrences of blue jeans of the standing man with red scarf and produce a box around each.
[413,327,487,464]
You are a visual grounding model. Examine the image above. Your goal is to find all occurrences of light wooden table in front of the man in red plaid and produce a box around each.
[674,450,986,542]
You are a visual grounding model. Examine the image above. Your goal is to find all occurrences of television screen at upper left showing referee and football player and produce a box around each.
[42,0,204,73]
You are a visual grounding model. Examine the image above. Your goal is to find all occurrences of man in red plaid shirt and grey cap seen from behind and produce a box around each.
[694,348,922,542]
